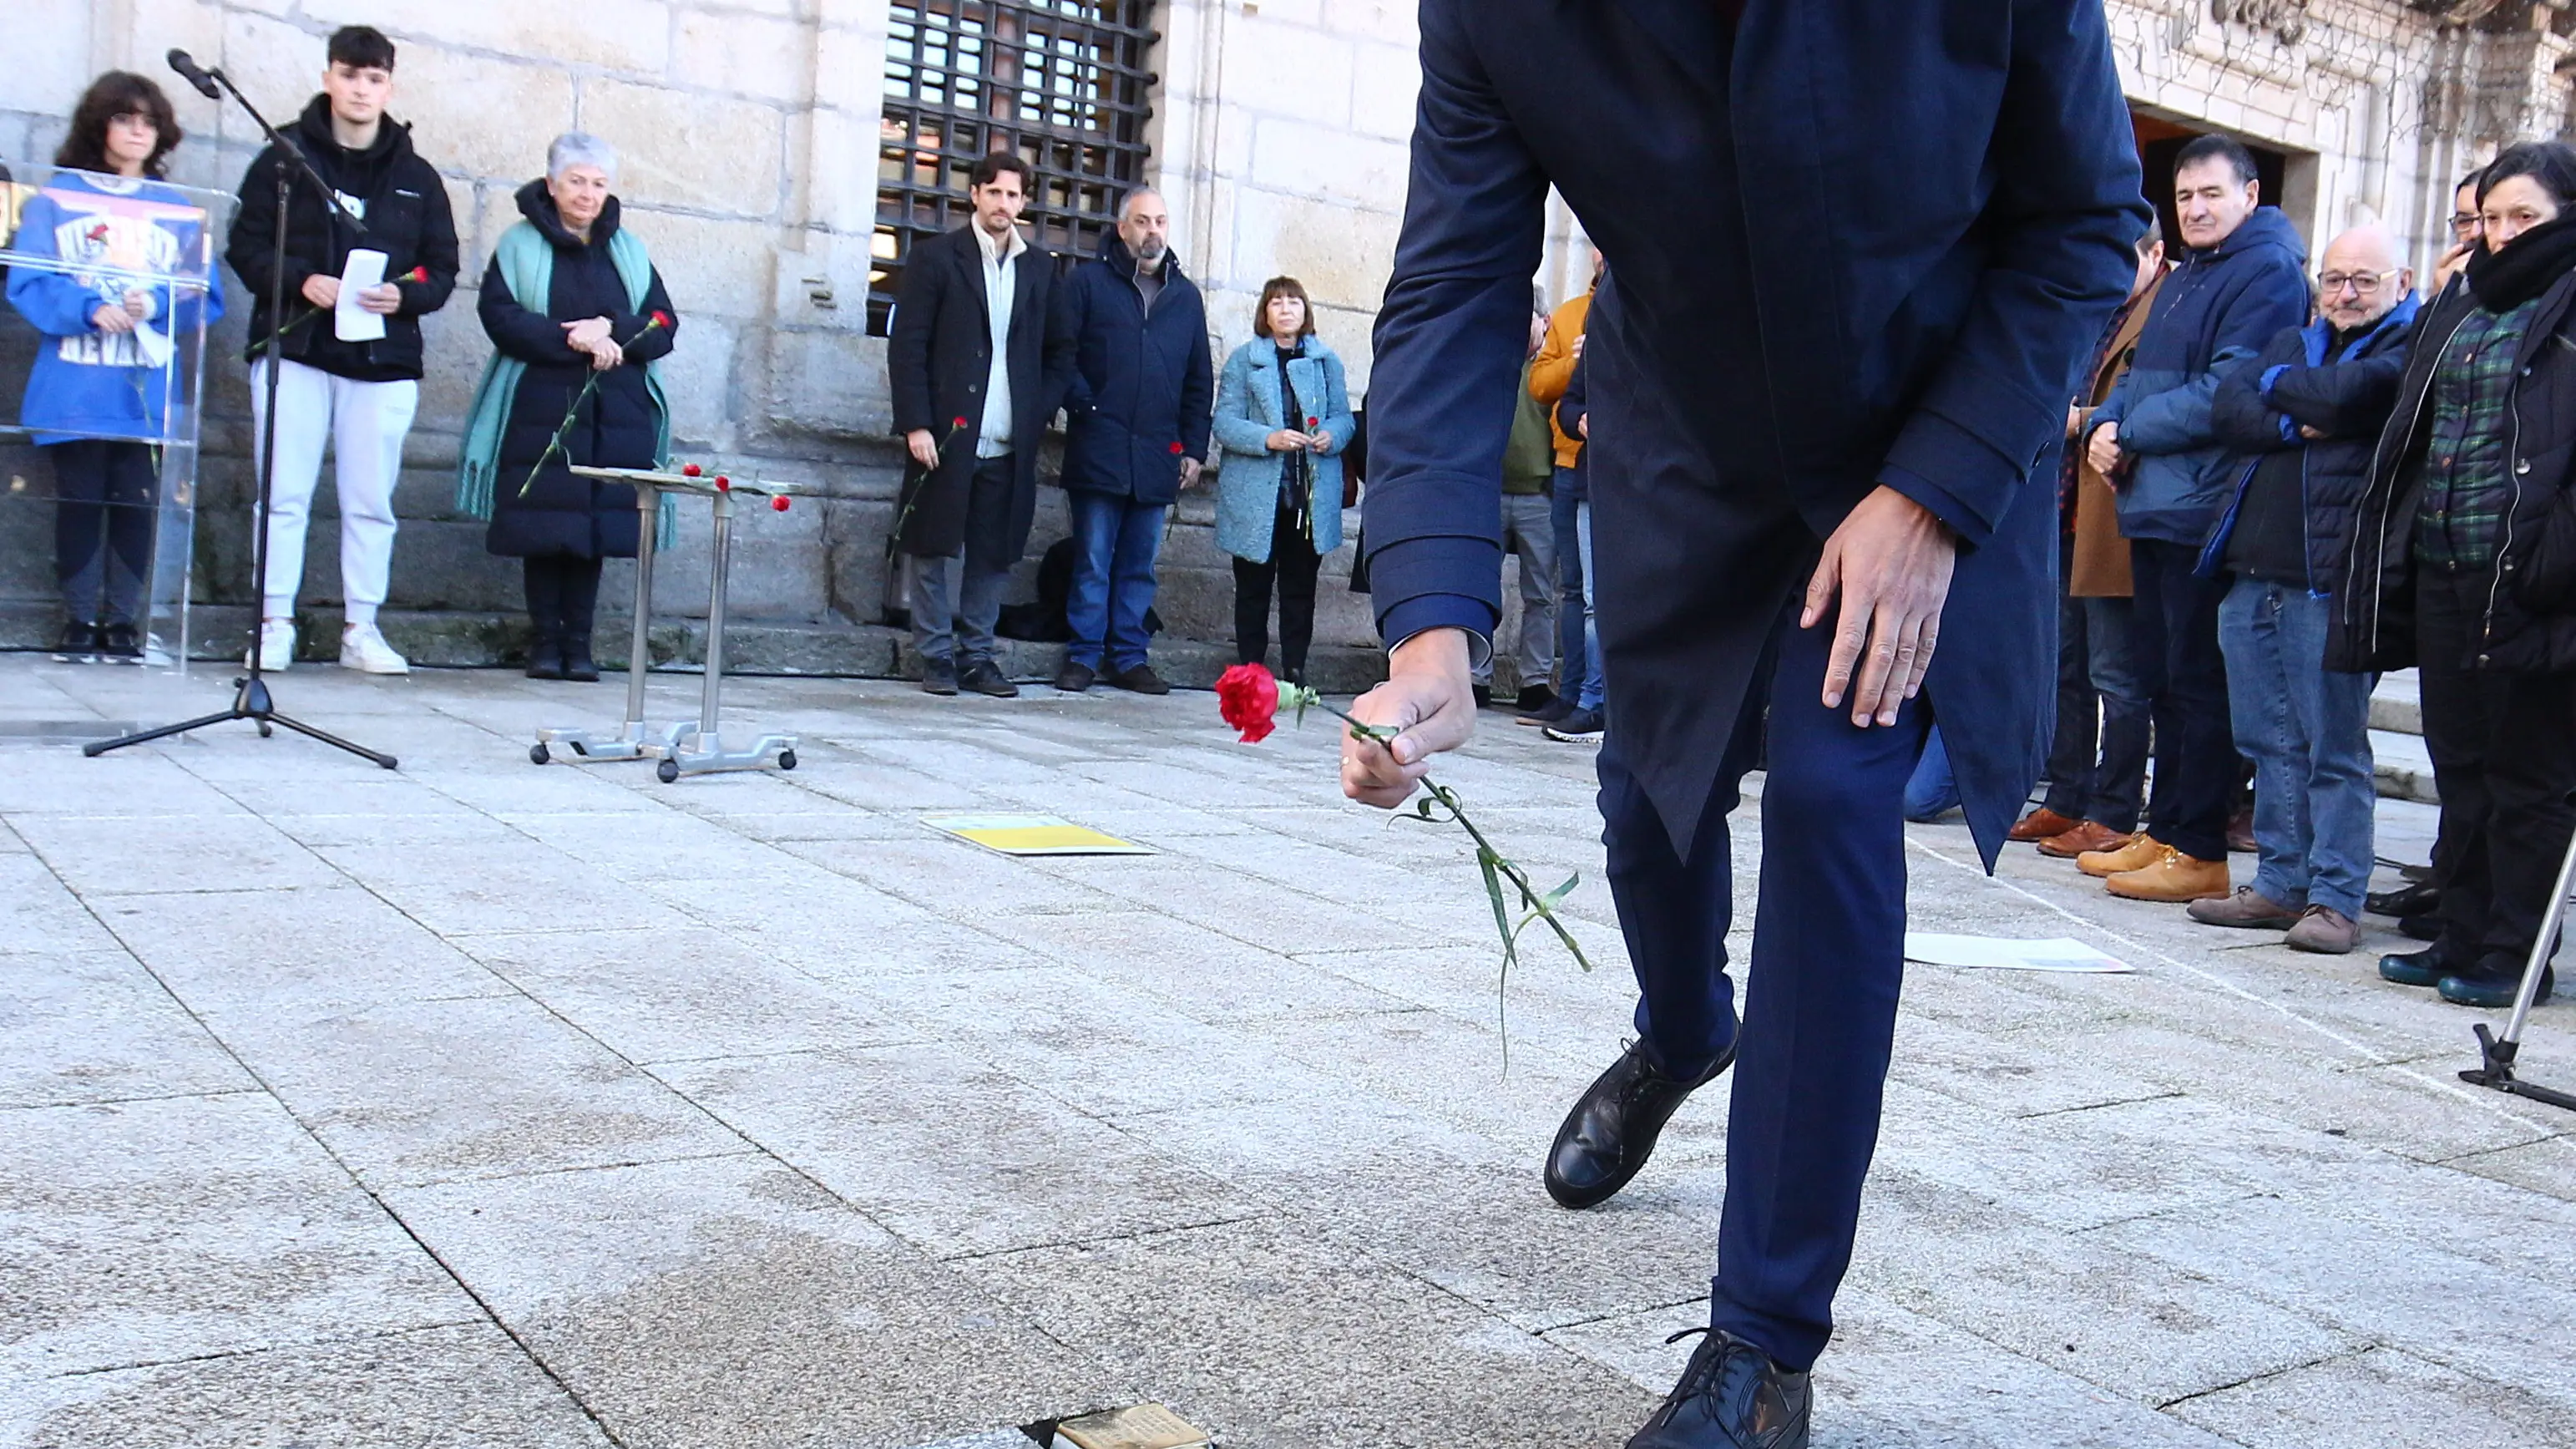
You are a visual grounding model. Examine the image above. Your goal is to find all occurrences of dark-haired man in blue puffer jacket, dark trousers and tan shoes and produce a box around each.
[2077,137,2308,903]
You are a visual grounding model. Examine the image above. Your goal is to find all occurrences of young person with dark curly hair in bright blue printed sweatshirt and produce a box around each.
[8,69,224,662]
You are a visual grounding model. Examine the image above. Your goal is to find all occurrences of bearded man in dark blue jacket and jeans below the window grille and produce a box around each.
[1051,190,1216,693]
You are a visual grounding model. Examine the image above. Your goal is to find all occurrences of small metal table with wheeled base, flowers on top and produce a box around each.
[528,467,796,784]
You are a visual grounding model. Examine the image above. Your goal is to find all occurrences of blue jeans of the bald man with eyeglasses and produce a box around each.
[2218,578,2377,920]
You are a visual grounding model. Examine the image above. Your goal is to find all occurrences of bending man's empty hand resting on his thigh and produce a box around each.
[1798,487,1958,730]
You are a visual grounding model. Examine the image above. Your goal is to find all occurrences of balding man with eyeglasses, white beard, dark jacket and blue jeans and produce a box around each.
[2189,227,2417,956]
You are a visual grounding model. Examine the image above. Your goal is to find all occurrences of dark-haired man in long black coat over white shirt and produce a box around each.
[886,152,1064,699]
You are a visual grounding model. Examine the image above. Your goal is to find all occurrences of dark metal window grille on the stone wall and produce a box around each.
[868,0,1156,335]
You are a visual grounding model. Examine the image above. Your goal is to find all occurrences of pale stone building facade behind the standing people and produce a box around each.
[0,0,2571,673]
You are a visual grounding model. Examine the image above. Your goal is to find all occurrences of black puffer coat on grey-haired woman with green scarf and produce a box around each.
[479,180,677,560]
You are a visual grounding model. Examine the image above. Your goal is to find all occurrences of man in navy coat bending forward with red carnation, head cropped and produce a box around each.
[1342,0,2148,1449]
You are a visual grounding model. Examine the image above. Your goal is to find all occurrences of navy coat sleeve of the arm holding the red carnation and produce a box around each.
[1368,0,1548,645]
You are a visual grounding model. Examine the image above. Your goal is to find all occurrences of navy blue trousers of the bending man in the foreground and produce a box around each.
[1600,603,1930,1369]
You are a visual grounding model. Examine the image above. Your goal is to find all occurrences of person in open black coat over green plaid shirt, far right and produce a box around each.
[2326,142,2576,1006]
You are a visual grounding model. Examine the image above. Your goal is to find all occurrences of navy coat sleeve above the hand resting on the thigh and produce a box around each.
[1878,0,2148,546]
